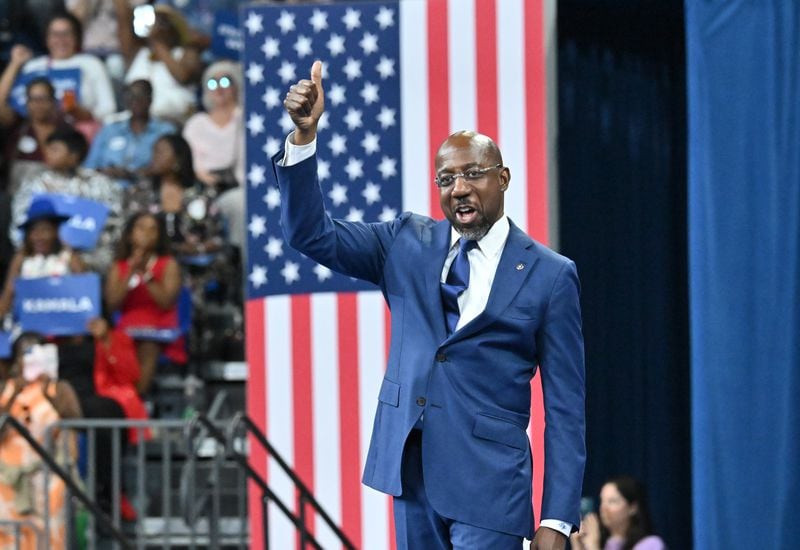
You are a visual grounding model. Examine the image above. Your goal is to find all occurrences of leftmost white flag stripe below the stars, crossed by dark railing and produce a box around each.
[265,296,295,548]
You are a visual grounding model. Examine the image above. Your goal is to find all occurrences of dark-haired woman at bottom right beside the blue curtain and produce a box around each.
[570,476,666,550]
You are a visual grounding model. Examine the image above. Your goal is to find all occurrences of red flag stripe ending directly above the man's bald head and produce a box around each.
[475,0,499,140]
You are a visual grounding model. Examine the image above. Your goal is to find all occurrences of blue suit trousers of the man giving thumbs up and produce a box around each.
[394,430,522,550]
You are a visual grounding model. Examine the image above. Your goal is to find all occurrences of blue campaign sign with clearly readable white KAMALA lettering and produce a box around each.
[14,273,100,336]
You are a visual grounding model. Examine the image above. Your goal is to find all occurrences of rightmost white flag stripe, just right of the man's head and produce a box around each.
[496,0,528,230]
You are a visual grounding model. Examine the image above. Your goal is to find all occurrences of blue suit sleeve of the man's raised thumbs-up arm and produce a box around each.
[273,151,406,285]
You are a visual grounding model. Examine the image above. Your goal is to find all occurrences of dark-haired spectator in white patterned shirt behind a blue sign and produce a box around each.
[11,130,122,273]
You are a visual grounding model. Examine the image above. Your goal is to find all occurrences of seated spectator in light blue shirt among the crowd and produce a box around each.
[83,80,175,187]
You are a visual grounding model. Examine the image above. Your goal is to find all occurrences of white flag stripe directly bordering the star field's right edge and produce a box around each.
[400,1,435,220]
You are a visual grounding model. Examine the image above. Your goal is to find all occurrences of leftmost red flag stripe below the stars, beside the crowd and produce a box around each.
[245,299,267,548]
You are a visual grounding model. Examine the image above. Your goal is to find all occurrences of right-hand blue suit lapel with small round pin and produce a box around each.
[450,220,539,341]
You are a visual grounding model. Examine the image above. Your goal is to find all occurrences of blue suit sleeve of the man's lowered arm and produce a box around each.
[537,260,586,526]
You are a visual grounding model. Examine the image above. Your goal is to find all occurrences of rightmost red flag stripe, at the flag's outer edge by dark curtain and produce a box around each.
[525,2,548,526]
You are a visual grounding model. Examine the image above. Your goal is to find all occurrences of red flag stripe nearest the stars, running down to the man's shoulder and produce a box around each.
[427,0,450,219]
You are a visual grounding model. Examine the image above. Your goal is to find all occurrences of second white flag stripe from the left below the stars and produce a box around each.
[310,292,342,548]
